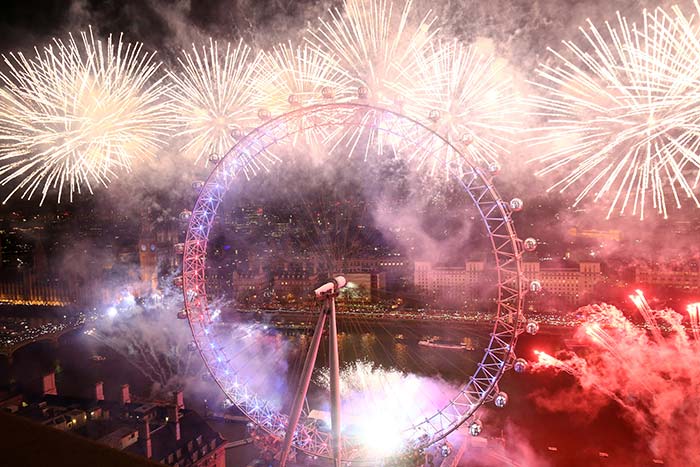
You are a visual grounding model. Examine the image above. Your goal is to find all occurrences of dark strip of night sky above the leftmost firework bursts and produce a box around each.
[0,0,322,53]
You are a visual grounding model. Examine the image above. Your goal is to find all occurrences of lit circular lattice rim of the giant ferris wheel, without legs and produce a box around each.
[182,103,524,461]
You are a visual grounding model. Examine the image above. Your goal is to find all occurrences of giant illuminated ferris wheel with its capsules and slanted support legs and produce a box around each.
[182,103,536,465]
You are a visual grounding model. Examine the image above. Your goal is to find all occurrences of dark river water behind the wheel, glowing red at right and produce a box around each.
[0,324,653,466]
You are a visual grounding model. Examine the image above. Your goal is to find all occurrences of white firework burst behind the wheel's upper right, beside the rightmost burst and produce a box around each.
[396,40,521,170]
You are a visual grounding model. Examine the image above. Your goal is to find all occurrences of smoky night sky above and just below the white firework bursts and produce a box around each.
[0,0,697,250]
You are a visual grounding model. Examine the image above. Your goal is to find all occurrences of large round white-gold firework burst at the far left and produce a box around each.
[0,29,172,203]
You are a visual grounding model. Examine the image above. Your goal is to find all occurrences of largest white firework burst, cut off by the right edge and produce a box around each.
[530,3,700,219]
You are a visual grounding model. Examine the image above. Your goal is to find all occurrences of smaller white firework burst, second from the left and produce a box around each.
[168,39,260,162]
